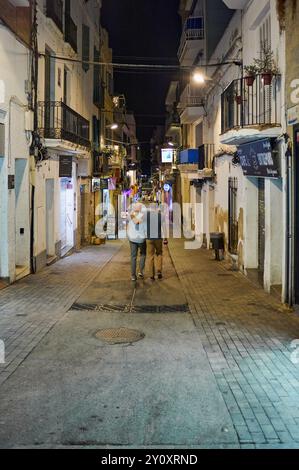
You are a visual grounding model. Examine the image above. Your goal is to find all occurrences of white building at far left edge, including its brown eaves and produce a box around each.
[0,0,33,288]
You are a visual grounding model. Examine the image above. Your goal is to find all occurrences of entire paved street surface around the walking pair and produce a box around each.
[0,240,299,448]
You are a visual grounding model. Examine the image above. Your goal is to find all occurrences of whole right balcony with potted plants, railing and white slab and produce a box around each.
[220,75,282,145]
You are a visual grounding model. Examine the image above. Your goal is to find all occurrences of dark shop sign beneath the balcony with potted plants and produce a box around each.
[238,139,280,178]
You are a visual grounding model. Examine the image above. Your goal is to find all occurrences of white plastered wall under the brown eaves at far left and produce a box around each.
[0,25,30,281]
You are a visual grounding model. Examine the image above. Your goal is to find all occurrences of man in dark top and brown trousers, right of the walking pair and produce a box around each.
[147,208,163,281]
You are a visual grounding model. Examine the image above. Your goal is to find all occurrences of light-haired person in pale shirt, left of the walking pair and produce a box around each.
[128,203,146,282]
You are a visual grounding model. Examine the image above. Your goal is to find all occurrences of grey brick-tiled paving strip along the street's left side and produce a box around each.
[0,242,122,386]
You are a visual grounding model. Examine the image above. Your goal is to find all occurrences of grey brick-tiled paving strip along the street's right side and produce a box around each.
[169,240,299,448]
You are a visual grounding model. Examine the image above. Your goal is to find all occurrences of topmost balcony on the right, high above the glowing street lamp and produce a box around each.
[178,16,205,66]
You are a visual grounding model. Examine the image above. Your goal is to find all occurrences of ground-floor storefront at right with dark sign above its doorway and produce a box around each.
[238,139,284,292]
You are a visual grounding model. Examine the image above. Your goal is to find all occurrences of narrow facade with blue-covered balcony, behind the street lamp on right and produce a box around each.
[176,0,233,235]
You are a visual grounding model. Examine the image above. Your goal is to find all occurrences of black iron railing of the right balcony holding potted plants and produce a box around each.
[221,75,281,134]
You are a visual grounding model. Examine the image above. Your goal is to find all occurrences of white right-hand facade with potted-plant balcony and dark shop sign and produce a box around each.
[197,0,286,295]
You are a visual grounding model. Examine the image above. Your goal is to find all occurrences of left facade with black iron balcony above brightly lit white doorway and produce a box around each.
[34,0,104,271]
